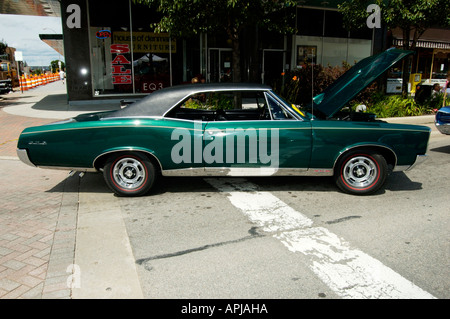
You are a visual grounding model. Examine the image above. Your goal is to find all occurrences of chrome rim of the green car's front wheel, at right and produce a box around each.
[343,156,378,188]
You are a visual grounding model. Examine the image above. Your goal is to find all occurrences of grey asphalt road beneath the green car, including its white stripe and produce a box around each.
[76,134,450,299]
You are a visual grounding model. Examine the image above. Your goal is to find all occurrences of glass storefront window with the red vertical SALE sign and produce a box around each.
[89,1,176,96]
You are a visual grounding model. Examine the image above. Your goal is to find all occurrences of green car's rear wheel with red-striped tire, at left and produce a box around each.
[103,152,156,196]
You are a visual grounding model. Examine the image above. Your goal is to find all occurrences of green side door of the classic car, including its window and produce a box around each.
[203,92,311,176]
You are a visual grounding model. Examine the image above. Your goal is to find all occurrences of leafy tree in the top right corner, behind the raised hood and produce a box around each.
[339,0,450,97]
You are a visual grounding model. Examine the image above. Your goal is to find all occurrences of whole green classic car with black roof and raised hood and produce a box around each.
[17,49,430,196]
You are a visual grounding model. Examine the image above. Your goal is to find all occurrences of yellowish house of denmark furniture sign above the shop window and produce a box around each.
[113,31,177,53]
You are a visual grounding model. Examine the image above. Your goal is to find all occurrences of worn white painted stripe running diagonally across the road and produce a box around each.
[205,178,435,299]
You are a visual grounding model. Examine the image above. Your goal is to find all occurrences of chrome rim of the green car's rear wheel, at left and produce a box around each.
[113,157,146,190]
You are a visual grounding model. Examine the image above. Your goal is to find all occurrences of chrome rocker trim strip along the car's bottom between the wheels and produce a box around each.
[161,167,334,177]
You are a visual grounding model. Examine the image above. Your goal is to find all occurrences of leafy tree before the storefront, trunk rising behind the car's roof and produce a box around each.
[134,0,296,82]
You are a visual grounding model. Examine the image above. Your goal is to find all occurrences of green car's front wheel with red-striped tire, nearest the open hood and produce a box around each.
[335,150,388,195]
